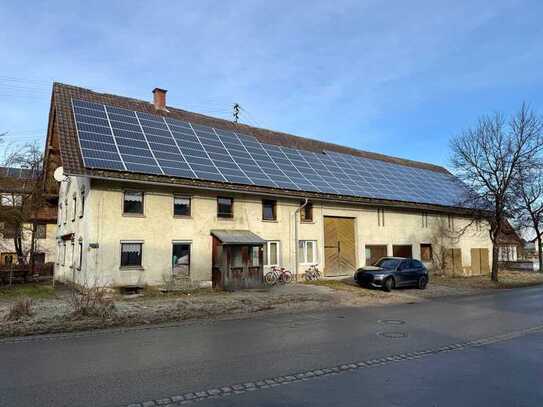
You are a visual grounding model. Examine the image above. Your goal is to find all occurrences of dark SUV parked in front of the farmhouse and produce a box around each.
[354,257,428,291]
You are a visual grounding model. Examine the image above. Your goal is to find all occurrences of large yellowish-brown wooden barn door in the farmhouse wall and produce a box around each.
[324,216,356,277]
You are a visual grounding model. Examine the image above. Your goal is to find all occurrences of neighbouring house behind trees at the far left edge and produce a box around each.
[0,167,57,266]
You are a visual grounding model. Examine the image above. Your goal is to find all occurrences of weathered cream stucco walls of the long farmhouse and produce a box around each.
[55,176,491,286]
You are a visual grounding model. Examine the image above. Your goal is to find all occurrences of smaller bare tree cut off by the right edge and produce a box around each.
[514,162,543,271]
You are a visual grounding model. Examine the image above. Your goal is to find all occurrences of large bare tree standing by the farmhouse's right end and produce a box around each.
[451,104,543,281]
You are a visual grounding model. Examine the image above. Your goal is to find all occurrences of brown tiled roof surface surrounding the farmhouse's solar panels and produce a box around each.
[48,83,472,212]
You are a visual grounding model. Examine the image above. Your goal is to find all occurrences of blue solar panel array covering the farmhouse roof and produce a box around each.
[72,99,464,206]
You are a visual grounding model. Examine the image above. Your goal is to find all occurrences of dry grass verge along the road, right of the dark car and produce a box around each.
[430,271,543,289]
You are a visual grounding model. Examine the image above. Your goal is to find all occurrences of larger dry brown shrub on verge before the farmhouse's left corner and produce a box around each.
[68,287,115,319]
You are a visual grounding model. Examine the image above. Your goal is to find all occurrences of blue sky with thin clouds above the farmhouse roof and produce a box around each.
[0,0,543,165]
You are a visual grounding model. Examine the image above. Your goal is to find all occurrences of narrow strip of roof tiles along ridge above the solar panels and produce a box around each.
[53,82,450,174]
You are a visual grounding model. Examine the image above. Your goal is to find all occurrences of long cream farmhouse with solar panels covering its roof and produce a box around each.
[44,83,491,287]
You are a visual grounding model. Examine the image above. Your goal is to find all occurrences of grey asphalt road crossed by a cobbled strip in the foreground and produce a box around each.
[0,287,543,407]
